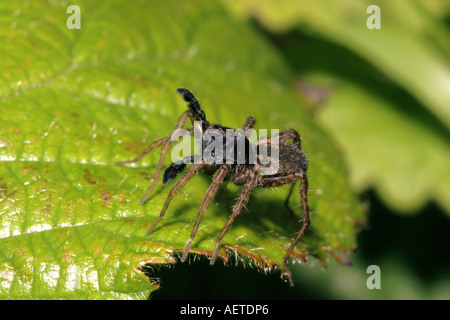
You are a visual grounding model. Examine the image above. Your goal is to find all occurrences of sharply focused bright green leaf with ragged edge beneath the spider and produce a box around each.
[0,1,364,299]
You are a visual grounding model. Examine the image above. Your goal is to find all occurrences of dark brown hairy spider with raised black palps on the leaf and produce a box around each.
[116,88,310,285]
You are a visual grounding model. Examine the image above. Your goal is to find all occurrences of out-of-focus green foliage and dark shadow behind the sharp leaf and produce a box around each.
[152,0,450,299]
